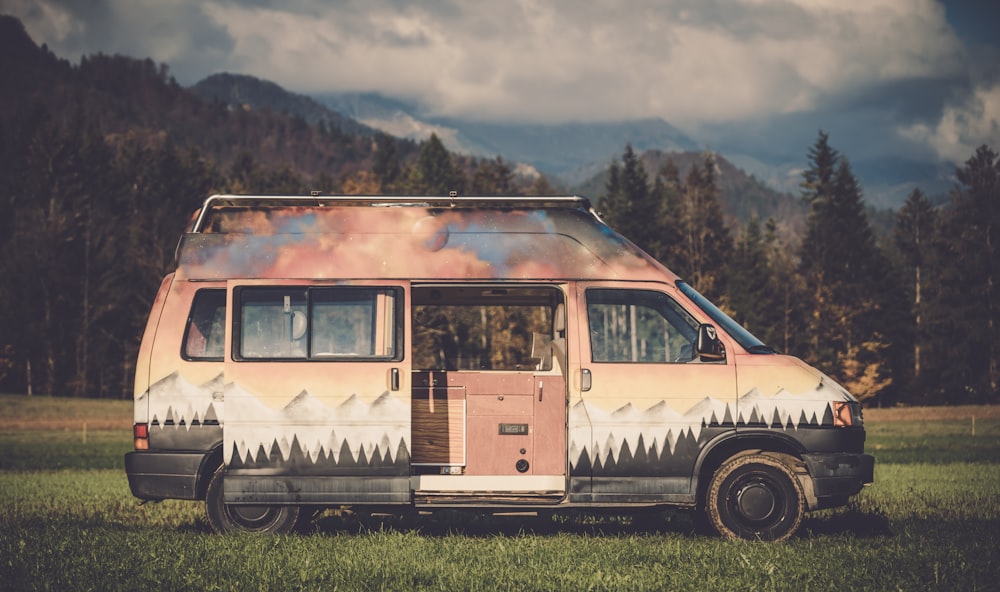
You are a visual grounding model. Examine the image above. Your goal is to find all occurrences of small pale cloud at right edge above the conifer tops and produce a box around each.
[899,84,1000,164]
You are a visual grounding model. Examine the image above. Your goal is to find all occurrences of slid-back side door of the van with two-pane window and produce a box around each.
[223,280,411,503]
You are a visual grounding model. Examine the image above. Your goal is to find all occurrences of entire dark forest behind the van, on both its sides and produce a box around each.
[0,91,1000,404]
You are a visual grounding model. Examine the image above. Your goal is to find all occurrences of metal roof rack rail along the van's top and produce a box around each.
[192,191,591,232]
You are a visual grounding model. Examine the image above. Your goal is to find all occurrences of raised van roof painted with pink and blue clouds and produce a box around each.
[177,195,676,281]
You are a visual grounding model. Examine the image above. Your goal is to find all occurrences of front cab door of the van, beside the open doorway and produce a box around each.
[570,282,736,502]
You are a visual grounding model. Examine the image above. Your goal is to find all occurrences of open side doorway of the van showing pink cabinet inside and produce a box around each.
[412,284,567,505]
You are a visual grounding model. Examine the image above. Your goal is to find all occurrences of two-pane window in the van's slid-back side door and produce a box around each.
[236,287,402,360]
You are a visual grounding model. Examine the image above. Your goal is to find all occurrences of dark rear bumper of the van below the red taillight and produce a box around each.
[125,450,208,500]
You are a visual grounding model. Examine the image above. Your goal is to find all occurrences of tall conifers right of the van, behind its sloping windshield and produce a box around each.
[598,131,1000,405]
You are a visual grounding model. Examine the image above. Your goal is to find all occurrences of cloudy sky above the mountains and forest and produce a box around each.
[7,0,1000,163]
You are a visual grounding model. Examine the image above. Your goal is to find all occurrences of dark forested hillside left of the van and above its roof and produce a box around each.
[0,103,552,397]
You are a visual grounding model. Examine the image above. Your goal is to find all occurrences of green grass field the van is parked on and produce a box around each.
[0,395,1000,591]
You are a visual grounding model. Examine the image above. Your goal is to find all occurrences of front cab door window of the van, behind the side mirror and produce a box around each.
[587,289,698,363]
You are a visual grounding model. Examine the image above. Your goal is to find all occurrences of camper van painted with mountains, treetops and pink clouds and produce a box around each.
[125,195,874,540]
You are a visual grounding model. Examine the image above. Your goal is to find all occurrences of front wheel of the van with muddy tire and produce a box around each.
[705,454,805,541]
